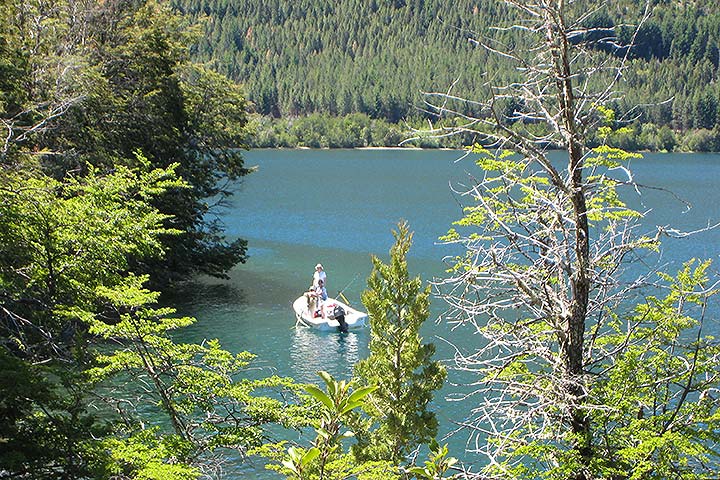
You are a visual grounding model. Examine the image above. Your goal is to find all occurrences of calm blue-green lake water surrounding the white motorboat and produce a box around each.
[165,150,720,478]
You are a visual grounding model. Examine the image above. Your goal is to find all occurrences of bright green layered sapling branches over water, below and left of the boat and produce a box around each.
[87,276,306,460]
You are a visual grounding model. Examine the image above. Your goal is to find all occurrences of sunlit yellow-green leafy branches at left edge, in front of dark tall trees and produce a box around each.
[0,156,184,355]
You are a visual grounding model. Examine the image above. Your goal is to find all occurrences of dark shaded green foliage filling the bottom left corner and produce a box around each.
[0,348,112,480]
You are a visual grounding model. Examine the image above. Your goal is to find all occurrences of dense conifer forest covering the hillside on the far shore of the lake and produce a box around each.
[176,0,720,150]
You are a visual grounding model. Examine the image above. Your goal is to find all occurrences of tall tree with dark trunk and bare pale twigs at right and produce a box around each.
[427,0,717,480]
